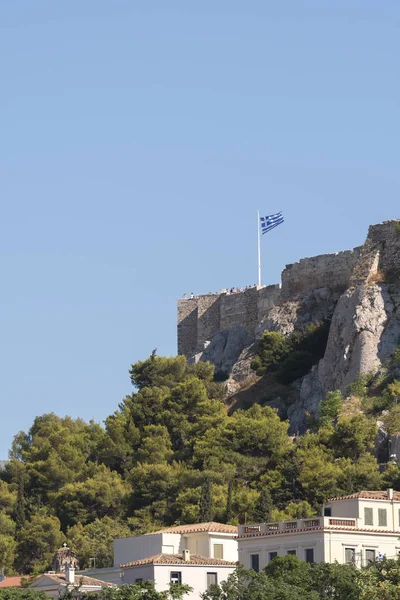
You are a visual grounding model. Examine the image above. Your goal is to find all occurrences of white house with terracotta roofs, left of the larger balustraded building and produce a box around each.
[114,523,238,600]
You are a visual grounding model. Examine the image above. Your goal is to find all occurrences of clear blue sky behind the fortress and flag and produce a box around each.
[0,0,400,458]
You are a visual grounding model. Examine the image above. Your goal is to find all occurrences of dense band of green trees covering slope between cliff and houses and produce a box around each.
[0,350,400,574]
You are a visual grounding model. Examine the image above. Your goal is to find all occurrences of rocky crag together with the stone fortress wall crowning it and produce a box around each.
[183,221,400,433]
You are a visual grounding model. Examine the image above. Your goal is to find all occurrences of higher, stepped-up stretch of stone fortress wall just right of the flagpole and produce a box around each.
[282,248,361,298]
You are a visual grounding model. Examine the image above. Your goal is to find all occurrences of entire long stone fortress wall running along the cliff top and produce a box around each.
[178,221,400,357]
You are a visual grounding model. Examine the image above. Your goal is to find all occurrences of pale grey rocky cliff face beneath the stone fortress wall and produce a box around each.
[190,221,400,432]
